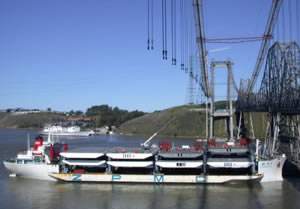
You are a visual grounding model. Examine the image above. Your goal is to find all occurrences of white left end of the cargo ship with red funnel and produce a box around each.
[3,136,67,181]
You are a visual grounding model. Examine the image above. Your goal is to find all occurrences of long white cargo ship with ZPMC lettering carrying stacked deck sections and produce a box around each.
[4,136,286,184]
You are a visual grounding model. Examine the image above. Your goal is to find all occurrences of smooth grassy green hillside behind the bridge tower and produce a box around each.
[117,105,266,138]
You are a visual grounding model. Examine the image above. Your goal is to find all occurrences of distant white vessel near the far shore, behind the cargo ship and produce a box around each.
[41,125,95,136]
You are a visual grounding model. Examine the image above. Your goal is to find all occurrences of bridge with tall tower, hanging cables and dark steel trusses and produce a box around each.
[147,0,300,168]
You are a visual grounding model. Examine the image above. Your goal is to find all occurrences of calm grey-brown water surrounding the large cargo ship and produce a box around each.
[0,130,300,209]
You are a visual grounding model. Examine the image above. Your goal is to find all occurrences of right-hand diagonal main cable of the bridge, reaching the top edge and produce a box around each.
[247,0,283,94]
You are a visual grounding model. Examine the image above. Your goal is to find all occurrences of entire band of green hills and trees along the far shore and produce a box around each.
[0,102,267,138]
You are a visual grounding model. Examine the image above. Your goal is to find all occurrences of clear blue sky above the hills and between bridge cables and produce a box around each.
[0,0,296,112]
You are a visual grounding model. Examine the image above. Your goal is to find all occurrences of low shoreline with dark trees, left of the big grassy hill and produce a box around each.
[0,105,145,128]
